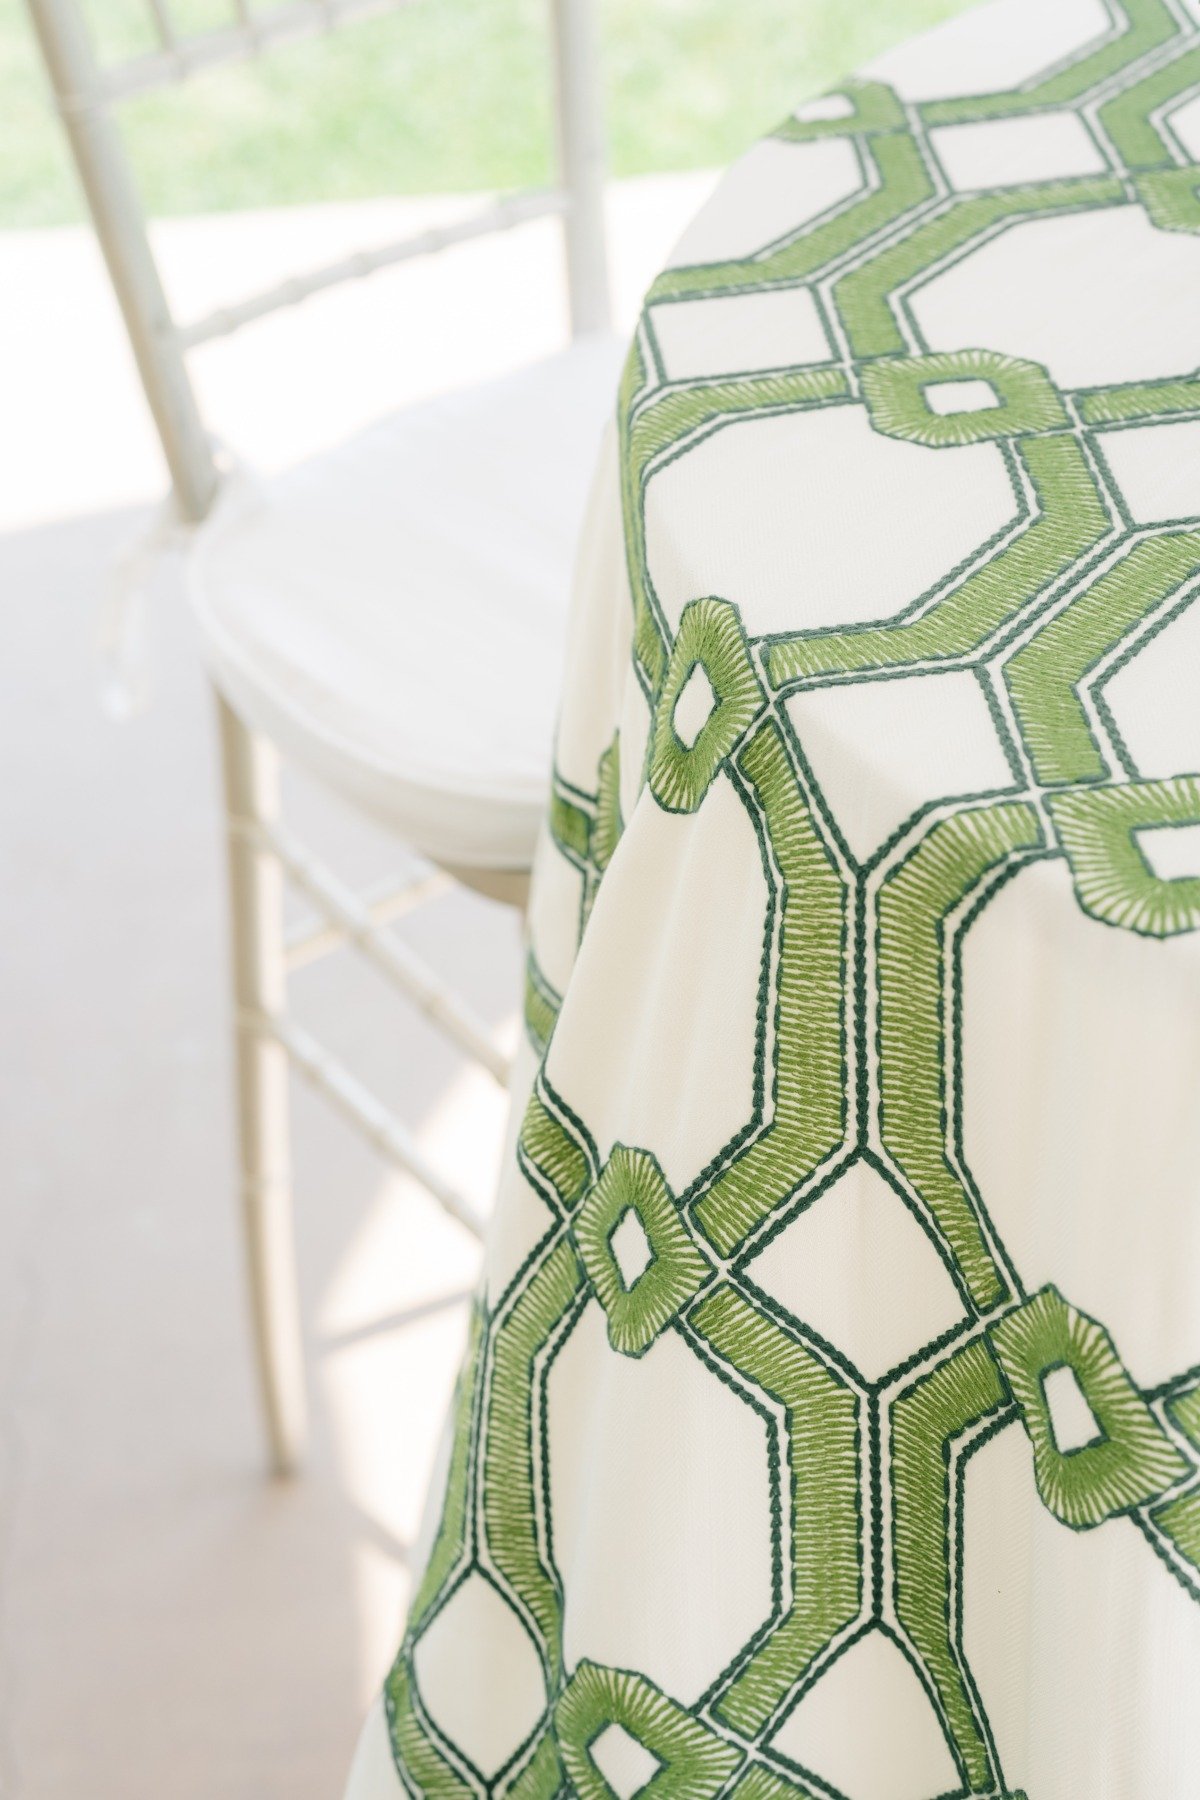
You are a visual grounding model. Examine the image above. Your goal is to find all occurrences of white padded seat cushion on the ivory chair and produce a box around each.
[191,337,621,869]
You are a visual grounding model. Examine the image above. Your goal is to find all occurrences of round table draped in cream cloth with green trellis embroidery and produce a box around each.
[351,0,1200,1800]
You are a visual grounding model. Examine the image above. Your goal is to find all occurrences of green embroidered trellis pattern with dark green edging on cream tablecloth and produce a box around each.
[377,0,1200,1800]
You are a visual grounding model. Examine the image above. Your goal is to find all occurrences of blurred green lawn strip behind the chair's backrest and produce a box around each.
[0,0,963,227]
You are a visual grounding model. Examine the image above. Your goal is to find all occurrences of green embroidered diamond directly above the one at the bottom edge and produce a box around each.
[576,1145,709,1355]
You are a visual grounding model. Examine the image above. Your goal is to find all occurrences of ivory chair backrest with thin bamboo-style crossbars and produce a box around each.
[29,0,610,520]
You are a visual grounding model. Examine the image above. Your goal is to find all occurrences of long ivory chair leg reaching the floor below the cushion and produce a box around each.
[218,695,306,1474]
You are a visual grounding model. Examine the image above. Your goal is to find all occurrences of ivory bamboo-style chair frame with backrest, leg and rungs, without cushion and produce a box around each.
[27,0,610,1474]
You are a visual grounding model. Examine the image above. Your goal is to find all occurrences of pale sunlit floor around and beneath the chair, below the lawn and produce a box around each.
[0,176,709,1800]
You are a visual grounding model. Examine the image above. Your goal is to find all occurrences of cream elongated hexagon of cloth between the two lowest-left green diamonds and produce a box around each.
[543,1301,779,1706]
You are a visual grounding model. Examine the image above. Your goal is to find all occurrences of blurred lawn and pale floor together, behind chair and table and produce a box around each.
[0,0,963,1800]
